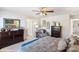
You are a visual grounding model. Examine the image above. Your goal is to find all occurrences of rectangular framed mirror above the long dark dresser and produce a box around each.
[4,18,20,29]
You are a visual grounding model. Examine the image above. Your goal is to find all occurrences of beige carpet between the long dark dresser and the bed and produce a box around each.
[0,42,22,52]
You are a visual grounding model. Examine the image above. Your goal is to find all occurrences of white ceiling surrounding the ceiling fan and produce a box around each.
[0,7,79,17]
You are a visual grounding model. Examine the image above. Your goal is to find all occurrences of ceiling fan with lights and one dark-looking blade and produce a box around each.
[32,7,54,16]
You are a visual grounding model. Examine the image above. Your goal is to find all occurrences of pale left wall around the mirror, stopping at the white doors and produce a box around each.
[0,10,27,38]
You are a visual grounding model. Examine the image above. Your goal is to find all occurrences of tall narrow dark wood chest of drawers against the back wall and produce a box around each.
[51,26,62,38]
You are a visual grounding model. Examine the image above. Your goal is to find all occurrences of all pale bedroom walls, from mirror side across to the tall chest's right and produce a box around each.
[0,11,70,38]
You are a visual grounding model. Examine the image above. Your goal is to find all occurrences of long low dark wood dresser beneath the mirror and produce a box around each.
[0,29,24,49]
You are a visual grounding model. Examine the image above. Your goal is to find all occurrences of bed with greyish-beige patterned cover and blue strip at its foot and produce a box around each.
[17,36,61,52]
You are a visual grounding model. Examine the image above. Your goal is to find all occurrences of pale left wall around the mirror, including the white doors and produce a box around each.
[0,10,38,39]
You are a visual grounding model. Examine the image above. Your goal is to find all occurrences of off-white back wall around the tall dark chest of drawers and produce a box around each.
[41,14,71,38]
